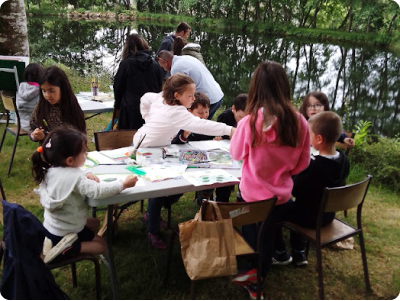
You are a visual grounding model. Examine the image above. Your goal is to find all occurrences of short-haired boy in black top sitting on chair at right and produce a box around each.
[272,111,350,266]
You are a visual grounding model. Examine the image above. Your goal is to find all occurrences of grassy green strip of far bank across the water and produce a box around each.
[27,9,400,52]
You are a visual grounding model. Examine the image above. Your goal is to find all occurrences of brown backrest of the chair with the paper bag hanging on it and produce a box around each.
[202,196,278,227]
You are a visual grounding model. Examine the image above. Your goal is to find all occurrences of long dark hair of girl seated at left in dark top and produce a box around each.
[36,66,86,134]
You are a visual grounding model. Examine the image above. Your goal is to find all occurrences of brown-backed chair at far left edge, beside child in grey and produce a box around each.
[0,95,29,176]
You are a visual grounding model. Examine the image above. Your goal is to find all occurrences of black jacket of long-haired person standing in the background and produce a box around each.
[114,50,163,129]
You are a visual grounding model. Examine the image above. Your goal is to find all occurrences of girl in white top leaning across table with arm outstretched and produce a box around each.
[133,73,235,249]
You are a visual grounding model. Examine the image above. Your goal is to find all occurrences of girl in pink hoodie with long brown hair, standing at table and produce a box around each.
[230,61,310,297]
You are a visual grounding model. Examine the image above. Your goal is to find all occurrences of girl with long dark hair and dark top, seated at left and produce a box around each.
[30,66,86,142]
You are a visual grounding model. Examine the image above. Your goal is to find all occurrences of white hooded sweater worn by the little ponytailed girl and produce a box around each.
[35,167,123,236]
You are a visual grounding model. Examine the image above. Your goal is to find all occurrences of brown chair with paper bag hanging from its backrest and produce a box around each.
[164,196,278,300]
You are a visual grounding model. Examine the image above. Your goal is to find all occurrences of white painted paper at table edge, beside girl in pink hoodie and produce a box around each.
[182,169,240,186]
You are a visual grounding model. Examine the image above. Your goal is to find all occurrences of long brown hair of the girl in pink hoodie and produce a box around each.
[246,61,299,147]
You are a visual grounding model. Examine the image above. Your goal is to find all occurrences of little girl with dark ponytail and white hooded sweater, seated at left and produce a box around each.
[32,127,138,263]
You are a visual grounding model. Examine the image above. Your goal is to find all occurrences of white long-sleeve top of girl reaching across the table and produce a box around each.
[133,92,232,147]
